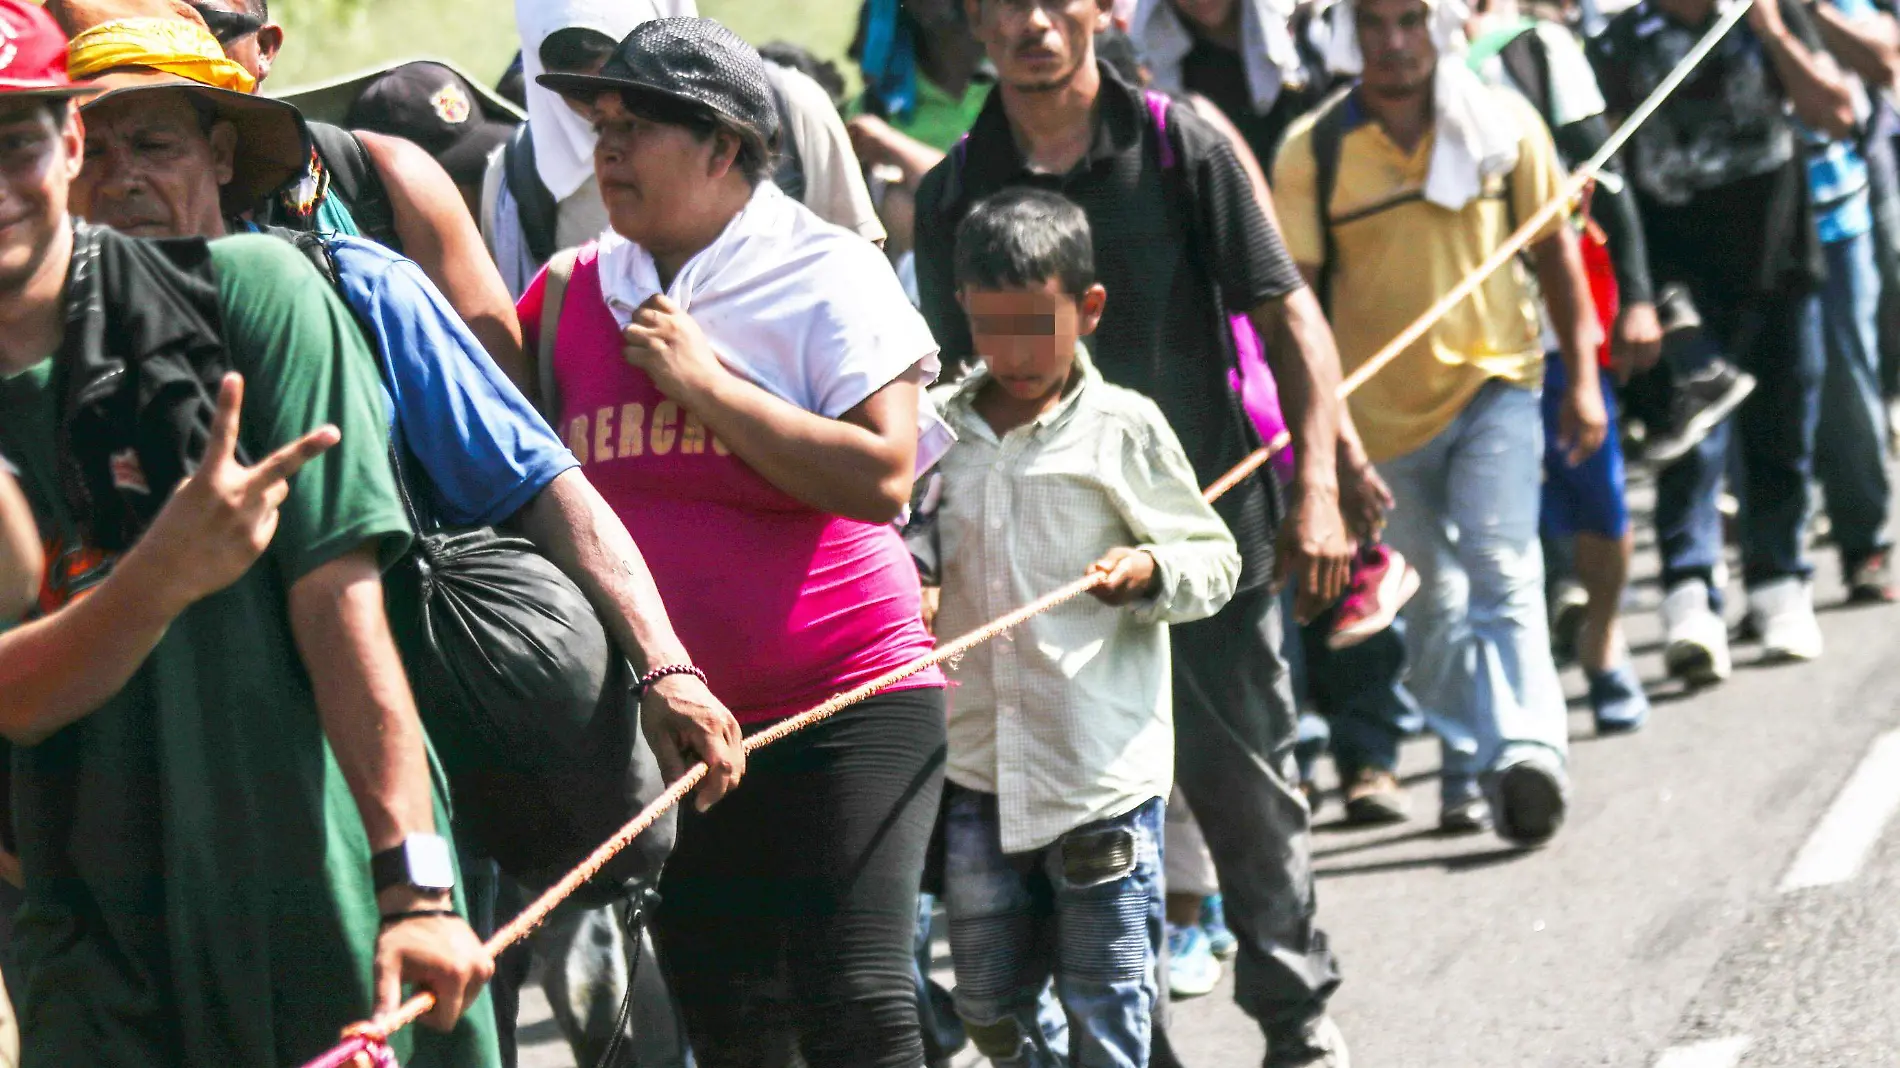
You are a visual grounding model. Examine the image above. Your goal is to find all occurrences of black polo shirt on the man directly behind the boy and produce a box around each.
[916,67,1303,589]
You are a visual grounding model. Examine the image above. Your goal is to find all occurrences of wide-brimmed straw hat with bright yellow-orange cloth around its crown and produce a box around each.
[46,0,310,203]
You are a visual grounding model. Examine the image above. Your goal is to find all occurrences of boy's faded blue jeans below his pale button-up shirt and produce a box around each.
[944,785,1163,1068]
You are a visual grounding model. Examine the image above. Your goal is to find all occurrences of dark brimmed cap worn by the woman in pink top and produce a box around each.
[536,19,779,150]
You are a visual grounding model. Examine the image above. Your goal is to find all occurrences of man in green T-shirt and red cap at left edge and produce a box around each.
[0,0,498,1068]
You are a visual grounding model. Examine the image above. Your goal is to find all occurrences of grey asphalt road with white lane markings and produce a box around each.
[523,475,1900,1068]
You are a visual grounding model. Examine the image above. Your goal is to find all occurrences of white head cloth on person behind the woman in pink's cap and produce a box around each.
[515,0,699,200]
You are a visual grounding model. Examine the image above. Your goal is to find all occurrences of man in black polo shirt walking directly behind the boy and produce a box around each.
[918,0,1383,1068]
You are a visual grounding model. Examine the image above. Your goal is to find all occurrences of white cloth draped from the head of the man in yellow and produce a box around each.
[1326,0,1524,211]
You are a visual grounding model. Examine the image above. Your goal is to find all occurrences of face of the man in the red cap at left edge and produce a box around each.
[0,97,84,296]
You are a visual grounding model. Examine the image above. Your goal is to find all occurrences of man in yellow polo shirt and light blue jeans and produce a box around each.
[1273,0,1606,846]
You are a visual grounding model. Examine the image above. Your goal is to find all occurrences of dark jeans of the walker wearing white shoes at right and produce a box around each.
[1655,289,1826,589]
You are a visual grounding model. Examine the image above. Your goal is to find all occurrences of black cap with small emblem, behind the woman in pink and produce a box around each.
[344,61,515,184]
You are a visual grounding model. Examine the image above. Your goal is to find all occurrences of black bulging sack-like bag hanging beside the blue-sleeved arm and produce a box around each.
[279,232,673,901]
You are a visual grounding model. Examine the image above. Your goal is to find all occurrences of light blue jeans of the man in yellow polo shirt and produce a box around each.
[1379,380,1568,802]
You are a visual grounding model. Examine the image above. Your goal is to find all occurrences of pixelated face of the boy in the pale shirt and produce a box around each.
[961,277,1108,404]
